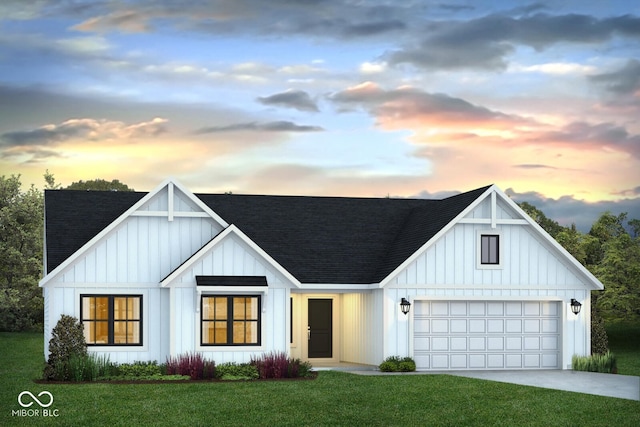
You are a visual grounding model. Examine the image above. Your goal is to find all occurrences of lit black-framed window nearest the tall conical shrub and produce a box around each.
[80,295,142,345]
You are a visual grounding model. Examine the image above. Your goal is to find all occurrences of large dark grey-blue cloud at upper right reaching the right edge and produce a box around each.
[384,13,640,70]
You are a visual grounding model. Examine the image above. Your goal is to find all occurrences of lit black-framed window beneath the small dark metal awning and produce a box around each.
[200,295,261,346]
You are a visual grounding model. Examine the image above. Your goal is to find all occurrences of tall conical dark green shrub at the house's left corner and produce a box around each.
[43,314,87,381]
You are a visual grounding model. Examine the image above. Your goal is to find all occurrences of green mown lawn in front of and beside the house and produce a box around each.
[0,328,640,427]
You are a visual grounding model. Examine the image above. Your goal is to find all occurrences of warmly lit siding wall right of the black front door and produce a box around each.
[340,289,384,365]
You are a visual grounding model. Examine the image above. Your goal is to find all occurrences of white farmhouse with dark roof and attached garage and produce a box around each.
[40,180,603,370]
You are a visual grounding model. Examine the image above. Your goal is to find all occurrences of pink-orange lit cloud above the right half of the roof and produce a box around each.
[329,82,528,128]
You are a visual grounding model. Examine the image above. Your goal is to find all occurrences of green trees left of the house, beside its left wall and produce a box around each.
[0,175,44,331]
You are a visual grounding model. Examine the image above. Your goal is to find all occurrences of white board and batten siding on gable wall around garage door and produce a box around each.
[384,197,591,369]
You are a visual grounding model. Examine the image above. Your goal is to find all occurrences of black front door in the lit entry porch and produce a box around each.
[308,298,333,359]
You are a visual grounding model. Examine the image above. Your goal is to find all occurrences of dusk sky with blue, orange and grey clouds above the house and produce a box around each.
[0,0,640,231]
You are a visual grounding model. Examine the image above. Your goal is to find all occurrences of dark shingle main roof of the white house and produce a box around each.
[45,187,488,284]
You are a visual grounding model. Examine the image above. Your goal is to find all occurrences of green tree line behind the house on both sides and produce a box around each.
[0,171,640,331]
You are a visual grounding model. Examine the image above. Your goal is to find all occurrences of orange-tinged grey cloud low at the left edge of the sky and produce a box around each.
[0,117,167,147]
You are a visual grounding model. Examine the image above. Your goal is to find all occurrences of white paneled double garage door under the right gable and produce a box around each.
[413,301,561,370]
